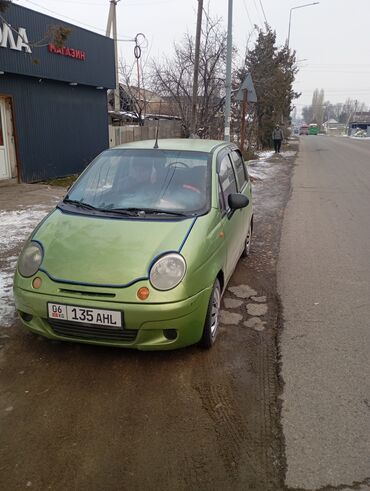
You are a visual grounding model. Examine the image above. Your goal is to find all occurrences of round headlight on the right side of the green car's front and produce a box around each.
[149,252,186,290]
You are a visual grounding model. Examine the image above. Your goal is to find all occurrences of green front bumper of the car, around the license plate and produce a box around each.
[14,286,212,350]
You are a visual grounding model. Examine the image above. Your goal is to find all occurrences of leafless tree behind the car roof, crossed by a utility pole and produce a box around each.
[151,13,226,138]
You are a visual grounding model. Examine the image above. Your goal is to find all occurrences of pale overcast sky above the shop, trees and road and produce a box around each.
[13,0,370,109]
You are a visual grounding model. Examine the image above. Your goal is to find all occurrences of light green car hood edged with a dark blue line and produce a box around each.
[32,209,194,286]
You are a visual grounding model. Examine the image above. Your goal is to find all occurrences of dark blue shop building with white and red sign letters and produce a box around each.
[0,4,115,182]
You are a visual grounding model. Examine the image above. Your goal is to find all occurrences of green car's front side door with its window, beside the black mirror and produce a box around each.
[217,148,244,283]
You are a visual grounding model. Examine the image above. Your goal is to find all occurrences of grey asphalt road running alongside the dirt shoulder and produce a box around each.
[278,136,370,490]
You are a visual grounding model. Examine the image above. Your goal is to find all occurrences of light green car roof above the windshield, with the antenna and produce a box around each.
[114,138,230,153]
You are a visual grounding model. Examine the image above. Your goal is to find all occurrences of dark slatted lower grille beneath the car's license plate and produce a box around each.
[48,319,138,342]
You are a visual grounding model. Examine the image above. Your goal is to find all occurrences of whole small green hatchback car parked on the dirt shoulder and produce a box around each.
[14,139,253,350]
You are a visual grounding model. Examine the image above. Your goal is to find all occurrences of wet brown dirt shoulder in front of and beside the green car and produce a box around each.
[0,143,297,491]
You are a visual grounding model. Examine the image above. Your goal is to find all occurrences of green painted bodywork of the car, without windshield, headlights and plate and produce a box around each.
[14,140,253,350]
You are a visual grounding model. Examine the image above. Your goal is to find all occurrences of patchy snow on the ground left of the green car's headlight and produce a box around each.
[0,205,50,328]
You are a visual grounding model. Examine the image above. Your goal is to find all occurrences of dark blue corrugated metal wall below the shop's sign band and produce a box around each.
[0,73,109,182]
